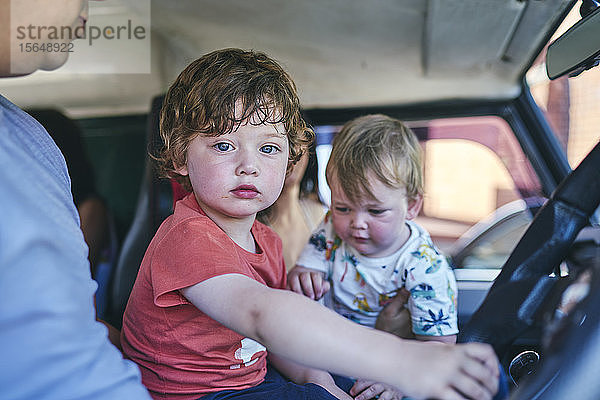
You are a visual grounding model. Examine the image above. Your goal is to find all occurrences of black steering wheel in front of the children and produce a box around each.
[458,143,600,399]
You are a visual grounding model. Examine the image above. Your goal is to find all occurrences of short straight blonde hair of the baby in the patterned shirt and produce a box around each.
[326,114,423,202]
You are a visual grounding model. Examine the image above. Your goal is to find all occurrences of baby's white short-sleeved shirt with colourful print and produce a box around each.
[297,214,458,336]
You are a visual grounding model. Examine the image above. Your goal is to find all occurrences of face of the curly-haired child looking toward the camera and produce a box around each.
[177,115,288,224]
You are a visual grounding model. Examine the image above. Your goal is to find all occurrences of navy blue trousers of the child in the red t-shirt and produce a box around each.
[200,365,354,400]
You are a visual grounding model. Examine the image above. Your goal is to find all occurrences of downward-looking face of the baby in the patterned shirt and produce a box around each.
[328,173,422,257]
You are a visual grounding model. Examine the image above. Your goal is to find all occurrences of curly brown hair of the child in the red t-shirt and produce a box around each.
[153,49,314,190]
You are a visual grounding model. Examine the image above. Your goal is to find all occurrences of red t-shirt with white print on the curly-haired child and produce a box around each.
[121,195,286,400]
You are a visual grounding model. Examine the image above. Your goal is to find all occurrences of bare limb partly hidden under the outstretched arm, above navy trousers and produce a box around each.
[268,353,352,400]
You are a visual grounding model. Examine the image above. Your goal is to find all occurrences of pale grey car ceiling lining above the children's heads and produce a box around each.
[0,0,572,114]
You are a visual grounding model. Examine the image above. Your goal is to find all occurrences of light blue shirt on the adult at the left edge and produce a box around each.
[0,104,149,400]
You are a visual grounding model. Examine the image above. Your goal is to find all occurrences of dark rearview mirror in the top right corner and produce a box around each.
[546,8,600,79]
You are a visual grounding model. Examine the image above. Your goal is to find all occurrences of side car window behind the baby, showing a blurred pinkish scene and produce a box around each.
[315,116,542,268]
